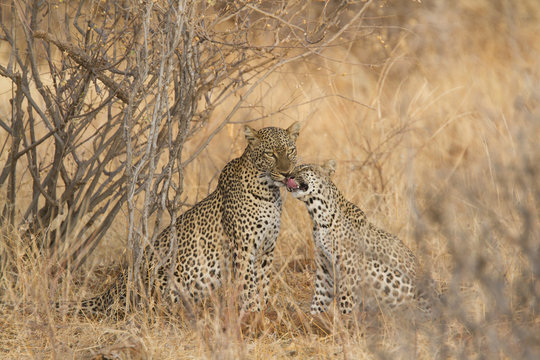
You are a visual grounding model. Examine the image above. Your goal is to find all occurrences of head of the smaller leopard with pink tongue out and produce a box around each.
[286,160,336,200]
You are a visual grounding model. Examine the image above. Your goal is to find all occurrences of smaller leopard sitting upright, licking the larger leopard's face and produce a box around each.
[287,160,429,314]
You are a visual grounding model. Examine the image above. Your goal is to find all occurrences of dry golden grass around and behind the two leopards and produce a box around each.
[0,0,540,359]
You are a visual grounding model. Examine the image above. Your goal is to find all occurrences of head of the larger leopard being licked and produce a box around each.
[244,122,300,184]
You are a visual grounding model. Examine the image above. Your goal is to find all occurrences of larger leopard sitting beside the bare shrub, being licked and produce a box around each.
[76,122,300,314]
